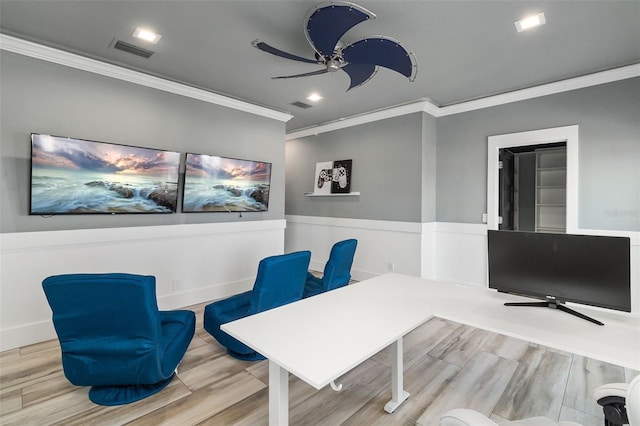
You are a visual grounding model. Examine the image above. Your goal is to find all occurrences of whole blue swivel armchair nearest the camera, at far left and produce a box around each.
[42,274,195,405]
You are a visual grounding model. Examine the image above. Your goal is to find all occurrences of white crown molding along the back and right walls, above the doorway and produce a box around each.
[285,64,640,140]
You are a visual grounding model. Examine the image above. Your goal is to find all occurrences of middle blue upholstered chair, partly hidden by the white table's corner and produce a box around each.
[204,251,311,361]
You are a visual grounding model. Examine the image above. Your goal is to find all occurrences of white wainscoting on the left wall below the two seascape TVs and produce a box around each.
[0,220,286,351]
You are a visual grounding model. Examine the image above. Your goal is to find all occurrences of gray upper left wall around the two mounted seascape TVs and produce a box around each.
[0,51,285,233]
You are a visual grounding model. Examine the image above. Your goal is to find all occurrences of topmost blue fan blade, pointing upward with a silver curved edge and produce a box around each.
[304,2,376,57]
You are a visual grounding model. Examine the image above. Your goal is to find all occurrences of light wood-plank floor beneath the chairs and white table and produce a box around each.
[0,298,637,426]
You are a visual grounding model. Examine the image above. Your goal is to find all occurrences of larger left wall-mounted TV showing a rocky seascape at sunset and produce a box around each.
[29,133,180,215]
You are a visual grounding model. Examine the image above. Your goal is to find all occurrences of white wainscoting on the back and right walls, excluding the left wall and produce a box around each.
[285,216,640,315]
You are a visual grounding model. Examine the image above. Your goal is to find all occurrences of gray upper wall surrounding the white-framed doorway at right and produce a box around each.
[436,78,640,231]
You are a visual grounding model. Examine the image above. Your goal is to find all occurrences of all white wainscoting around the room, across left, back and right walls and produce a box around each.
[0,216,640,351]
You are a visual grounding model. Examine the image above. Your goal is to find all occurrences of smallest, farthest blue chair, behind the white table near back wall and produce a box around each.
[303,239,358,297]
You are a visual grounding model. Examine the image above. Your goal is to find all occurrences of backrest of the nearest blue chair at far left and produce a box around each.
[42,273,161,386]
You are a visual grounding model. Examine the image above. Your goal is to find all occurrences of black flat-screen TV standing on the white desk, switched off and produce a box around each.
[487,230,631,325]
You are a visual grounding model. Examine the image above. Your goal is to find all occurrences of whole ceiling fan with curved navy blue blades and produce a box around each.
[251,1,418,91]
